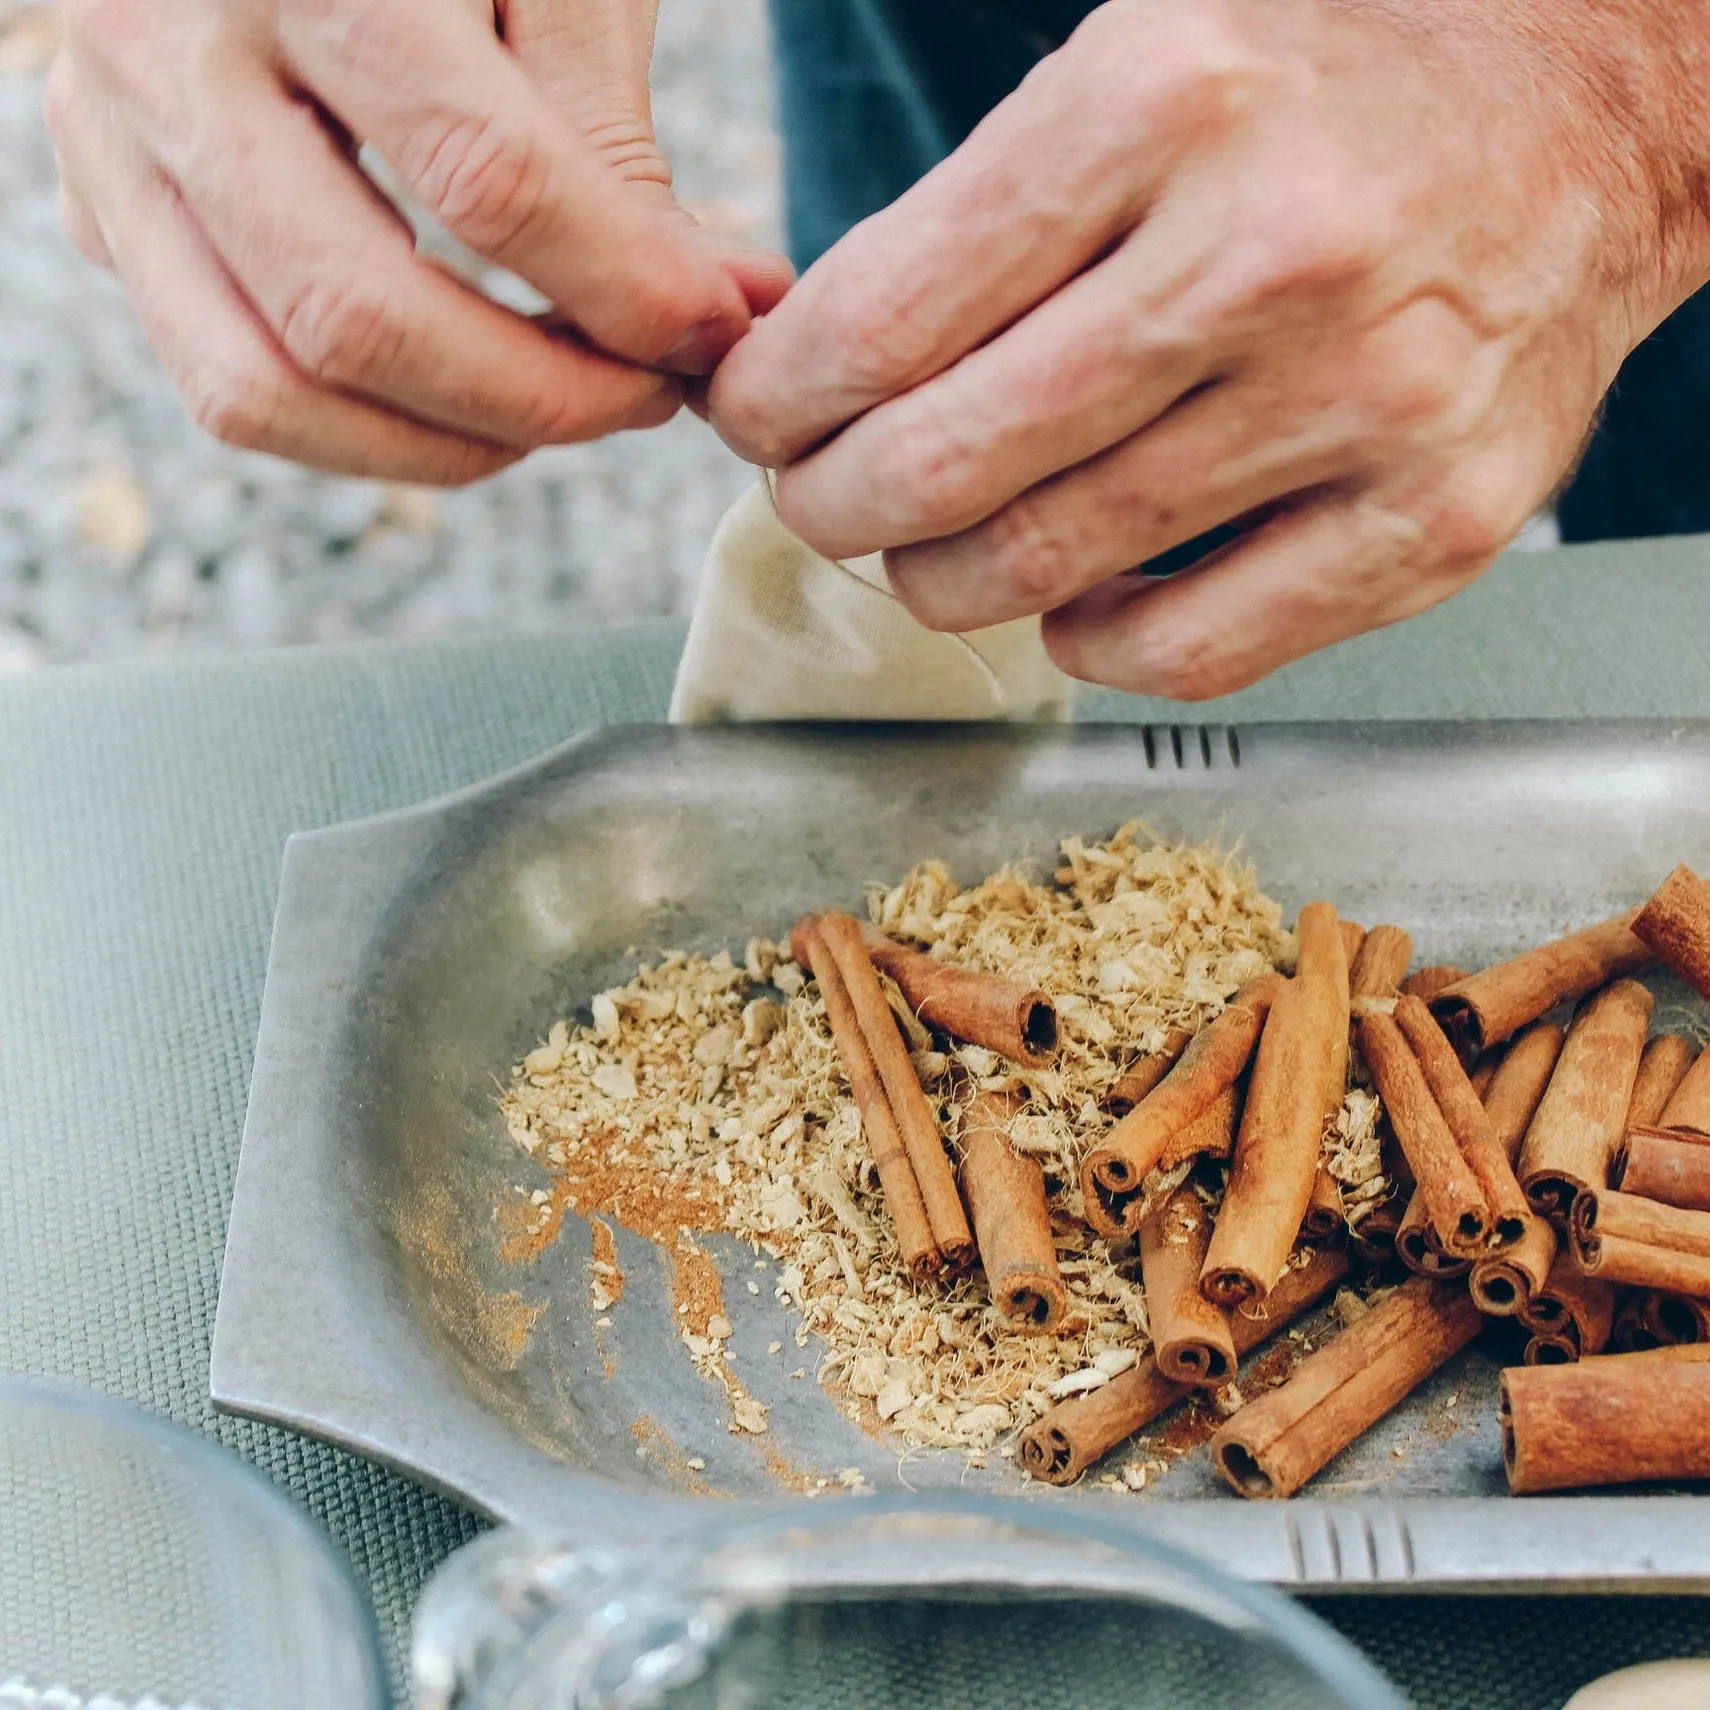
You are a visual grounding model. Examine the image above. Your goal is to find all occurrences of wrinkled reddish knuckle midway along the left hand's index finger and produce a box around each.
[405,113,552,255]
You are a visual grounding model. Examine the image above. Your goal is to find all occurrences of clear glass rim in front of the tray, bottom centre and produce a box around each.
[412,1496,1402,1710]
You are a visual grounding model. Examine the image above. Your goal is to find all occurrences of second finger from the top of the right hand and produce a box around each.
[778,221,1233,557]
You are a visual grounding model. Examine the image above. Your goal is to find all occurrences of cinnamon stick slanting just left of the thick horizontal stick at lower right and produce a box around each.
[1211,1277,1483,1498]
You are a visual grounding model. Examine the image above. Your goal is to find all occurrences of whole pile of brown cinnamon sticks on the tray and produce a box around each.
[793,867,1710,1496]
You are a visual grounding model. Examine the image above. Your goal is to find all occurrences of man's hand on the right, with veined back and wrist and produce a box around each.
[711,0,1710,698]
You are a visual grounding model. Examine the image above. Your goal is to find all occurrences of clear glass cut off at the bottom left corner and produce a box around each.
[0,1377,386,1710]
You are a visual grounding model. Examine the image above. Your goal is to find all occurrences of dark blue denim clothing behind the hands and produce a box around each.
[770,0,1710,540]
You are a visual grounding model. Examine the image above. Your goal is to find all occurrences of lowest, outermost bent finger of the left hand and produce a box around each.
[68,106,516,486]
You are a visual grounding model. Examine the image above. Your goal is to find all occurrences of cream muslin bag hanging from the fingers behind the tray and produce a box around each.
[670,472,1070,723]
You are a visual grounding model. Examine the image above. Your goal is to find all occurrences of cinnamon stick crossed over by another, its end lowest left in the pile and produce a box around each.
[1016,1247,1347,1484]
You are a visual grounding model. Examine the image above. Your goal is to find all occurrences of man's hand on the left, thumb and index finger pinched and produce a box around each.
[48,0,788,482]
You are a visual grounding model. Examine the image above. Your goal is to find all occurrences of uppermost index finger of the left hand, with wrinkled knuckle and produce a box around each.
[273,0,749,373]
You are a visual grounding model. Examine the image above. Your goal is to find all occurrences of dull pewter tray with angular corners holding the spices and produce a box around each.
[212,723,1710,1590]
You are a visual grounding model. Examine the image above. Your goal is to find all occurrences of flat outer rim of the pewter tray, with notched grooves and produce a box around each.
[209,718,1710,1594]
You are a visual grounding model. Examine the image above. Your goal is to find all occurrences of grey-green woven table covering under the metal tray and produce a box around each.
[10,526,1710,1710]
